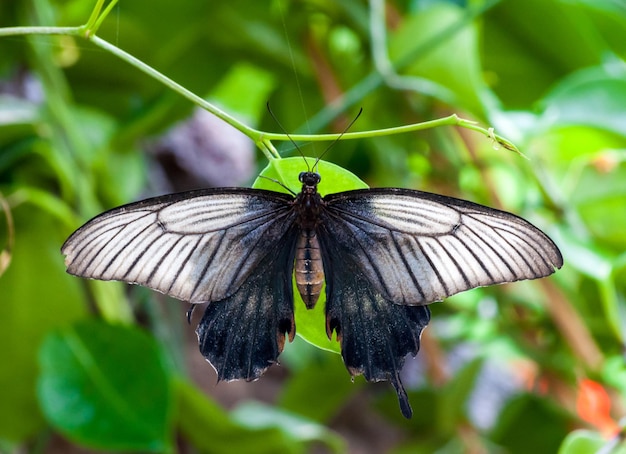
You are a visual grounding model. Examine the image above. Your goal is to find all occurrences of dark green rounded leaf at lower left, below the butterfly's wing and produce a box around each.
[37,321,172,452]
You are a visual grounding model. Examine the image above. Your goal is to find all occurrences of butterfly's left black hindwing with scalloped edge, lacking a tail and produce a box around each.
[196,228,297,381]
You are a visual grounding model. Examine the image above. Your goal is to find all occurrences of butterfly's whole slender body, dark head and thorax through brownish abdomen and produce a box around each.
[293,172,324,309]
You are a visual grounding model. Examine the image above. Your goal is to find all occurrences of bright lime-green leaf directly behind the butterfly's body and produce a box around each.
[253,158,368,353]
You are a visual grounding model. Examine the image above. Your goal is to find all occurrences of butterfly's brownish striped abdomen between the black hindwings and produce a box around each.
[295,230,324,309]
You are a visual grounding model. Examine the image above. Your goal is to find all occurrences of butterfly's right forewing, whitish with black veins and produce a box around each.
[322,189,563,305]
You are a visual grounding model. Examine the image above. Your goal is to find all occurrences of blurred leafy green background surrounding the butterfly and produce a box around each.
[0,0,626,453]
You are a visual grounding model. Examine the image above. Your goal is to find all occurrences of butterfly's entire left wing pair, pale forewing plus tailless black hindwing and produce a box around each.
[62,188,297,380]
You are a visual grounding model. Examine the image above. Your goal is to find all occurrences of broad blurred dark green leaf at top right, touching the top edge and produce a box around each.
[481,0,608,109]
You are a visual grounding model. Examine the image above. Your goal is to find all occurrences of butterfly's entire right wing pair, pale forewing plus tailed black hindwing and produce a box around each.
[318,189,563,417]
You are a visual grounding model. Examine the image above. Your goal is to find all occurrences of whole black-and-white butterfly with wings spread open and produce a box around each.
[62,157,563,418]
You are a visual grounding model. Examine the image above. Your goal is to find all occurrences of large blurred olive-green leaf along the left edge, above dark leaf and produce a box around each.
[0,204,86,441]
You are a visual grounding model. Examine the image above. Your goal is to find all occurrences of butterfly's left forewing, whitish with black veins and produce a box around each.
[62,188,294,303]
